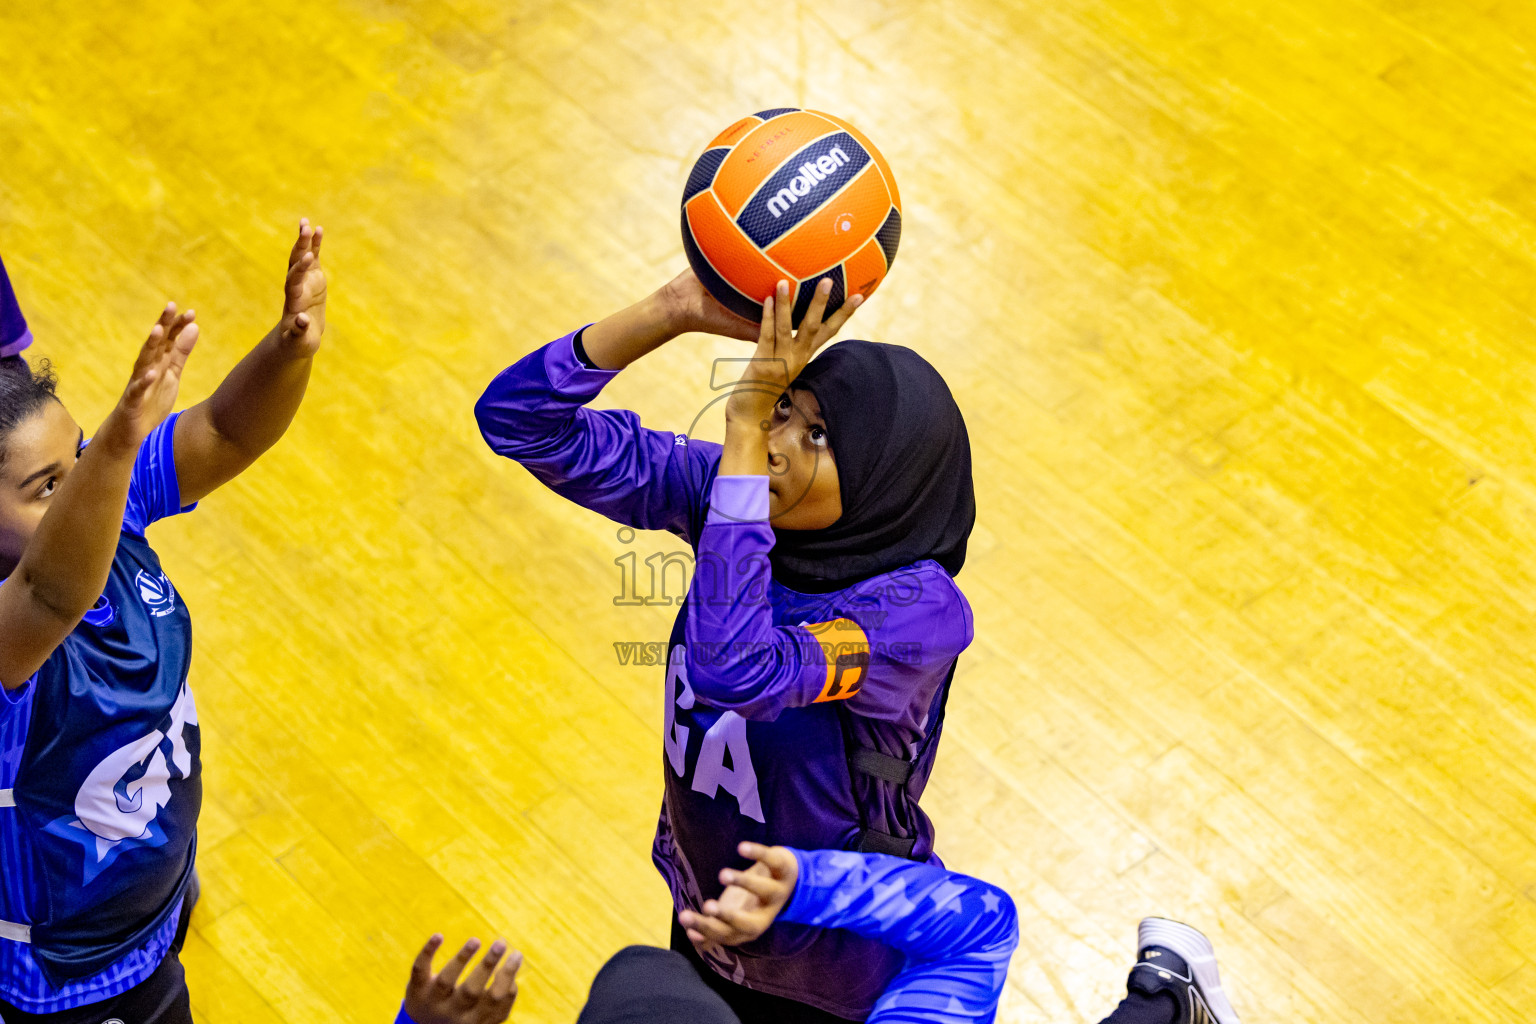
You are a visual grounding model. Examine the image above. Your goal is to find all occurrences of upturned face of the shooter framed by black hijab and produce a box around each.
[768,388,843,530]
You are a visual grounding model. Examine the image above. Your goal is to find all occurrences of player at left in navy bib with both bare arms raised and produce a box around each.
[0,221,326,1024]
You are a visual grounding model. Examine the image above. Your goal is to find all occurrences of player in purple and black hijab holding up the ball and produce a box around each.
[476,272,975,1024]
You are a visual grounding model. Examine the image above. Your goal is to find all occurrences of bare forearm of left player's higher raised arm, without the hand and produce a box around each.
[175,324,315,505]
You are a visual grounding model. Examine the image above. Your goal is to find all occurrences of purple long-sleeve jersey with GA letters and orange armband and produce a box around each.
[475,335,972,1018]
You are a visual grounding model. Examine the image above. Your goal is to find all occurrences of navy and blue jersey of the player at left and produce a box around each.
[0,418,203,1013]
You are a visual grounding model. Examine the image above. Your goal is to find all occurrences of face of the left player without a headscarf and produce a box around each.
[0,402,84,576]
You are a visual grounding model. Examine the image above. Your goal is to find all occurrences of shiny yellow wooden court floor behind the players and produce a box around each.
[0,0,1536,1024]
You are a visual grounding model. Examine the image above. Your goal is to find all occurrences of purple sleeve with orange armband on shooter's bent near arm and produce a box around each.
[684,476,972,729]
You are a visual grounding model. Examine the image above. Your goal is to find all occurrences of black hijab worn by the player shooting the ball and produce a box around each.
[770,341,975,593]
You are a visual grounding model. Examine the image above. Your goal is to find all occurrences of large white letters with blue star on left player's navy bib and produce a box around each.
[45,684,198,886]
